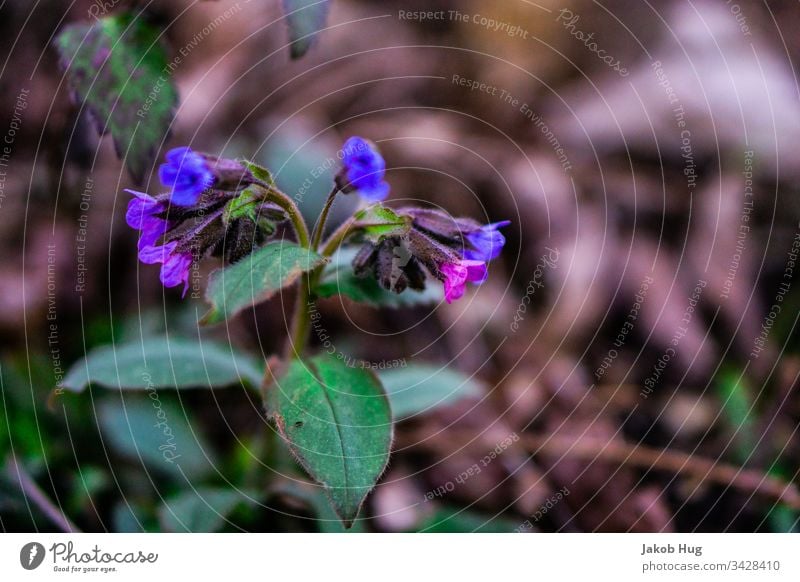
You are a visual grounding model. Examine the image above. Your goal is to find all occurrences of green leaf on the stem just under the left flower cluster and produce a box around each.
[202,241,325,324]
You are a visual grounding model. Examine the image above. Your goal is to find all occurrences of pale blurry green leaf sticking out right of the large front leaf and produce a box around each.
[378,364,483,420]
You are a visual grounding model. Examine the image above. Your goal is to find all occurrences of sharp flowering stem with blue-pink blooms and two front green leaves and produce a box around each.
[61,137,508,527]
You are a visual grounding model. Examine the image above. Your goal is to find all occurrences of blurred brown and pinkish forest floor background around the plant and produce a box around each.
[0,0,800,532]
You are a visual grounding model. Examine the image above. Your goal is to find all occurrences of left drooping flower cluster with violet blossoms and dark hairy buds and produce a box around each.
[125,148,286,296]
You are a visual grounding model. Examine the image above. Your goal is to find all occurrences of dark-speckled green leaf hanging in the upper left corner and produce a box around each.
[56,12,178,183]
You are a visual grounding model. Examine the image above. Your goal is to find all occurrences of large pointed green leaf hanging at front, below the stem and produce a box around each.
[267,355,393,527]
